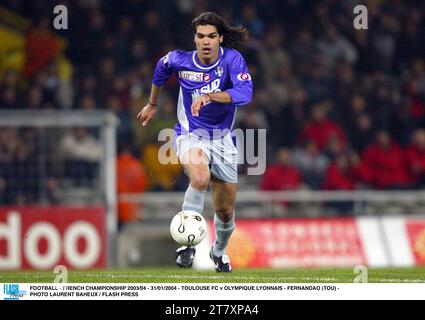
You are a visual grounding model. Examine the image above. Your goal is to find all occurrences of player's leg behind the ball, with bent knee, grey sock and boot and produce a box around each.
[175,148,210,268]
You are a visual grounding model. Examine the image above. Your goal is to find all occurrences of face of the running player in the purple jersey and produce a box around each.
[195,24,223,64]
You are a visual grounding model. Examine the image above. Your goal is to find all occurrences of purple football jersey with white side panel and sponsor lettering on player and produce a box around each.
[153,47,252,137]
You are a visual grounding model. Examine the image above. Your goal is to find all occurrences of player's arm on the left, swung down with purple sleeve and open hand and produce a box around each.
[137,52,173,126]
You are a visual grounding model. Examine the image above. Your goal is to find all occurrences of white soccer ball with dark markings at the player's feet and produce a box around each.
[170,210,207,247]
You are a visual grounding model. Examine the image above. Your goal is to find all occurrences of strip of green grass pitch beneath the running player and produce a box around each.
[0,267,425,283]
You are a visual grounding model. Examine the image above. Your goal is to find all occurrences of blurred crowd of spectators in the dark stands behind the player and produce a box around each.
[0,0,425,210]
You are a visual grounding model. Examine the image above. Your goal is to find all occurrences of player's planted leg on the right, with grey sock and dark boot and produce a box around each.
[210,176,237,272]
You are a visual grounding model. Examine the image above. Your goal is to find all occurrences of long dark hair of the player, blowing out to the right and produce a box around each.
[192,12,248,49]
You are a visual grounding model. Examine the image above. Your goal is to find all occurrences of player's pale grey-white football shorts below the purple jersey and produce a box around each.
[175,133,238,183]
